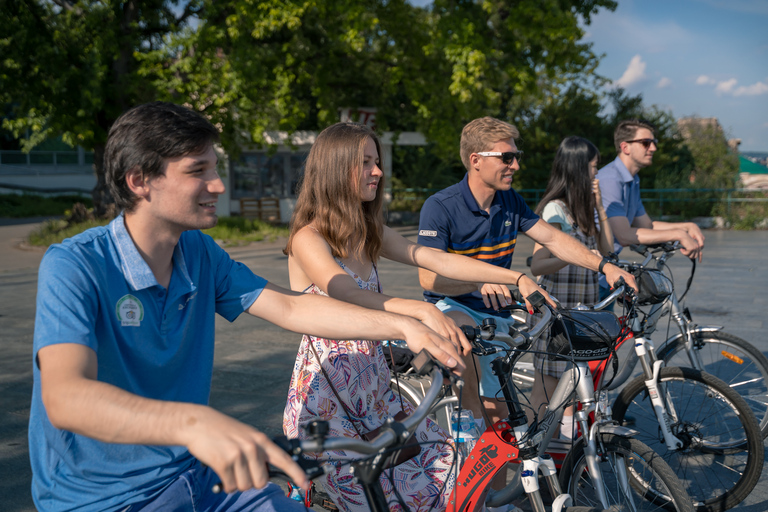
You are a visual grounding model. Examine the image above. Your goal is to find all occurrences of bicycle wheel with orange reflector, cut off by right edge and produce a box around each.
[657,331,768,438]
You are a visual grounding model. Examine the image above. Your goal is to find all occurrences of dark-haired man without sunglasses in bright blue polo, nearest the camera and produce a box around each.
[29,103,462,511]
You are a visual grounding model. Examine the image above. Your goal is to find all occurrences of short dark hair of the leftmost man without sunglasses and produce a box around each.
[104,101,219,212]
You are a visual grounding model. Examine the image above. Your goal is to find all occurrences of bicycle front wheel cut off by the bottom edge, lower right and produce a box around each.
[560,434,693,512]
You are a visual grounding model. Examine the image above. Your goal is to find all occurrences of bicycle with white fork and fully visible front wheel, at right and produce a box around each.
[594,274,764,512]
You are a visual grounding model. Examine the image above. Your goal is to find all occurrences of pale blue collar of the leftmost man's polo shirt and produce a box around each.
[109,213,195,291]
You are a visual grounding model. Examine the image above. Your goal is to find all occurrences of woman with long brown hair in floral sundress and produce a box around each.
[283,123,552,511]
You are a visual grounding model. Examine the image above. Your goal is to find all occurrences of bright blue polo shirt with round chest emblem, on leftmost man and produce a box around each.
[29,215,266,511]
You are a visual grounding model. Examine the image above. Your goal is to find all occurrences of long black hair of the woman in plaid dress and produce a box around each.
[536,136,600,236]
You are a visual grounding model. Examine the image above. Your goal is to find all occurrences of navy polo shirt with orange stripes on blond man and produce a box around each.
[419,175,539,315]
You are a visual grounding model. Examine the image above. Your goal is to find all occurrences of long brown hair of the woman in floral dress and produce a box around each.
[283,123,384,263]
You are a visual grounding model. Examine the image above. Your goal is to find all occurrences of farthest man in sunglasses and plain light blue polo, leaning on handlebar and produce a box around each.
[597,119,704,261]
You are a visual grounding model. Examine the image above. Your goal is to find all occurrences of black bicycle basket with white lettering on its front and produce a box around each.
[547,310,621,361]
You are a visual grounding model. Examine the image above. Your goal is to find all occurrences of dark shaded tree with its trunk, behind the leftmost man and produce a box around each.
[0,0,201,216]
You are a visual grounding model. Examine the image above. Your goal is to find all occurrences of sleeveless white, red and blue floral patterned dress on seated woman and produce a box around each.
[283,260,454,512]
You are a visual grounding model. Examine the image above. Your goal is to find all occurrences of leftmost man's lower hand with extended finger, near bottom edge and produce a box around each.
[186,406,309,492]
